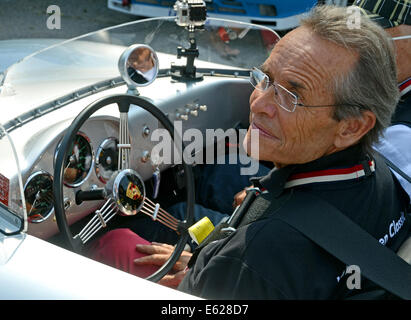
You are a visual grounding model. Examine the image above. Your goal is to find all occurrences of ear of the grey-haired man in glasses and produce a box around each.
[334,110,376,149]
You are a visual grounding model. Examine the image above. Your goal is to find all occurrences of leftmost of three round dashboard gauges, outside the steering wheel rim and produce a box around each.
[24,171,54,223]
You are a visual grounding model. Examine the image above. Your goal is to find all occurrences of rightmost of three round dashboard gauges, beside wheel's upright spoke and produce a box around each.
[96,137,118,183]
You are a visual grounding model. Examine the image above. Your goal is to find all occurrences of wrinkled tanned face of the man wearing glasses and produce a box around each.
[244,27,357,167]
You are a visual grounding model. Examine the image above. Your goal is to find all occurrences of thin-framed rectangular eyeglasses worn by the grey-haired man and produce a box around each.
[250,67,359,112]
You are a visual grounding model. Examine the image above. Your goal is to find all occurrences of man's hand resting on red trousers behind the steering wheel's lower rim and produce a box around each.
[134,242,192,288]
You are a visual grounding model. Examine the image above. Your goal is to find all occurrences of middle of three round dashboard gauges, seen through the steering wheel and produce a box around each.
[63,133,93,187]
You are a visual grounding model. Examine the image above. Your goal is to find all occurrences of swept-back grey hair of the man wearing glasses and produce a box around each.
[301,5,399,151]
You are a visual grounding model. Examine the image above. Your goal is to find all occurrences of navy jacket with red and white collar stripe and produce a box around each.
[179,146,411,299]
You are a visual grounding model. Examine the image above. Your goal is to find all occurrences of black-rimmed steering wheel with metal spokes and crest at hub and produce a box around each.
[53,94,195,282]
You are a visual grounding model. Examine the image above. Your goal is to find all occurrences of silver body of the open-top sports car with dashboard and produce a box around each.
[0,18,278,299]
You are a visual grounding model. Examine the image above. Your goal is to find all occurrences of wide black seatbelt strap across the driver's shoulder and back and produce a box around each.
[276,191,411,300]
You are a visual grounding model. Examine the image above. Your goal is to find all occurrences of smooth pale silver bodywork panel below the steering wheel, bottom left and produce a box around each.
[0,234,198,300]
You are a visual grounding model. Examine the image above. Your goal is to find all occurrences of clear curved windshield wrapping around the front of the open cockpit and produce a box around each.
[0,17,279,125]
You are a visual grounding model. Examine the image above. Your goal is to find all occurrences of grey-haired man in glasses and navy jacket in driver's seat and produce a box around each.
[88,7,410,299]
